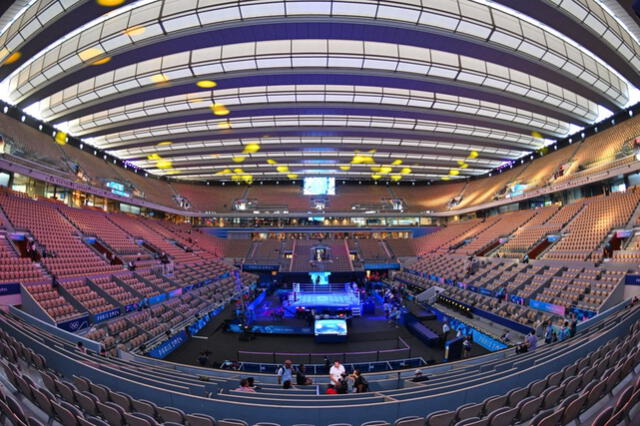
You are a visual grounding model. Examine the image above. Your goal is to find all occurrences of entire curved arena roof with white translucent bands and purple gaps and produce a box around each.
[0,0,640,182]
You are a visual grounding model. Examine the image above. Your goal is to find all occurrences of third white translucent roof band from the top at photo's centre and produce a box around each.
[60,85,569,136]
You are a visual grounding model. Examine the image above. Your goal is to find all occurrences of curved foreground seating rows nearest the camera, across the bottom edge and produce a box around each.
[0,296,640,425]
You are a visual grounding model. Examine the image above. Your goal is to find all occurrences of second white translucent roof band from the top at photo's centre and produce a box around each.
[37,40,598,121]
